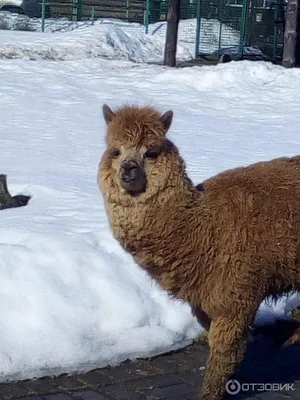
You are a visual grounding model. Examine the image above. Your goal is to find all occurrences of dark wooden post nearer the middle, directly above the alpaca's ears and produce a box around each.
[164,0,180,67]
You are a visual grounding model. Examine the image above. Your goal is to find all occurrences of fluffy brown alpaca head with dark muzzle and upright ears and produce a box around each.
[98,105,191,203]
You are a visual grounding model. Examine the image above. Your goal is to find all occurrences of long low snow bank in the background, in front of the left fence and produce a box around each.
[0,16,192,63]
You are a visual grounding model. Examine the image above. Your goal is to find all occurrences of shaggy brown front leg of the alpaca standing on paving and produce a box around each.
[200,317,248,400]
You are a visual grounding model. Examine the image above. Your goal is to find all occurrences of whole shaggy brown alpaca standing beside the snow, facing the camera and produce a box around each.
[98,106,300,400]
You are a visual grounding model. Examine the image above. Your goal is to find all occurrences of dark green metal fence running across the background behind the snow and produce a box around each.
[0,0,286,61]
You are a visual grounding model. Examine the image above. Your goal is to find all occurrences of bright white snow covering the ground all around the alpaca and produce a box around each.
[0,26,300,382]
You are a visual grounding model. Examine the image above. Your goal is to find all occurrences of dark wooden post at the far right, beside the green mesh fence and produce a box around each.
[282,0,299,68]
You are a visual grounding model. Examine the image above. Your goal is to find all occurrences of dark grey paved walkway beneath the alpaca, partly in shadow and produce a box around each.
[0,324,300,400]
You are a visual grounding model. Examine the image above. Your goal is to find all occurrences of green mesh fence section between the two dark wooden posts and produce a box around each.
[196,0,285,61]
